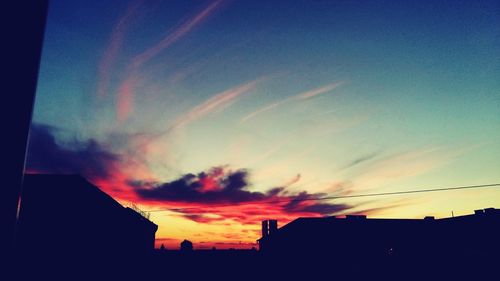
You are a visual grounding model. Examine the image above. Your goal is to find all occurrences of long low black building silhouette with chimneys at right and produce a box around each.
[258,208,500,277]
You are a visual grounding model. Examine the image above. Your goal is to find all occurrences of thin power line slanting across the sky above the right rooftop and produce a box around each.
[146,183,500,212]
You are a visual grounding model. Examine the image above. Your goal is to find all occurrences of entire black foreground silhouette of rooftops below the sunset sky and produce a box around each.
[10,175,500,280]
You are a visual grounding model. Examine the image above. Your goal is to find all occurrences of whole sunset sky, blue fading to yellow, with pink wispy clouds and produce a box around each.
[26,0,500,249]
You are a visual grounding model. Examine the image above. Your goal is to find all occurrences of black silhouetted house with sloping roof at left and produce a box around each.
[17,174,158,257]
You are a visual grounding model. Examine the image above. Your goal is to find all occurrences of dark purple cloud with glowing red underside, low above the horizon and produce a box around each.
[131,167,352,225]
